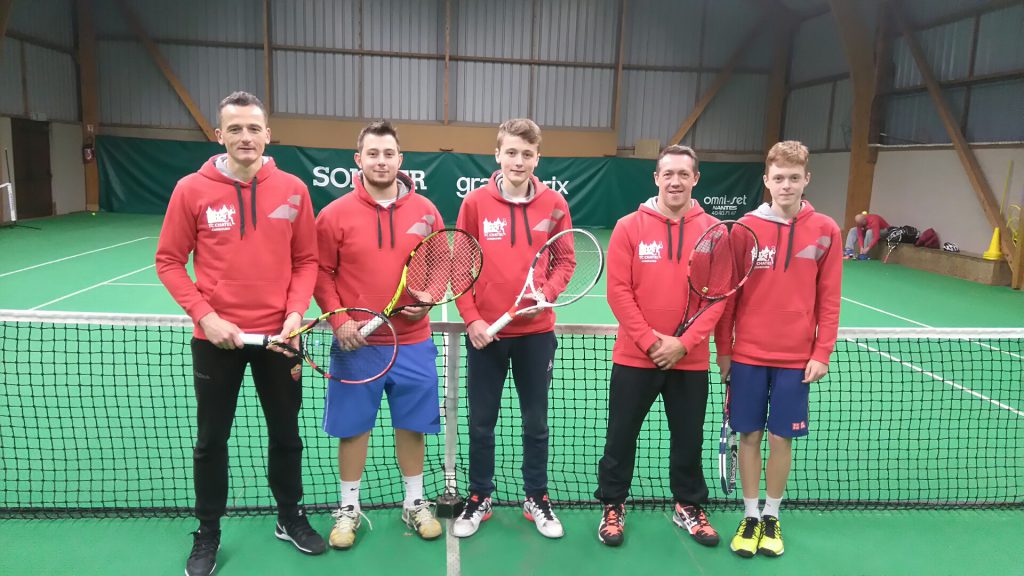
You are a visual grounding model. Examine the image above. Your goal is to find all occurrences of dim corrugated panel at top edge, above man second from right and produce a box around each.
[625,0,705,67]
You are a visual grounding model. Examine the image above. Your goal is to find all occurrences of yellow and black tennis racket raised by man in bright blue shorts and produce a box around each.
[359,228,483,337]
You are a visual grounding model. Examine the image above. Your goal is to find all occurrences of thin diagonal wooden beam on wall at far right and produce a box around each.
[893,6,1017,258]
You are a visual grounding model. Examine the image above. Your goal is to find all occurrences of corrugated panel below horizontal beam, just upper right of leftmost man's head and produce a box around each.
[273,50,361,118]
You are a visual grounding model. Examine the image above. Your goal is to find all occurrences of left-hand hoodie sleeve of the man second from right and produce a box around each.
[607,216,657,354]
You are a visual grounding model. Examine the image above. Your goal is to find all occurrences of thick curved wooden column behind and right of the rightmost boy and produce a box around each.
[828,0,876,228]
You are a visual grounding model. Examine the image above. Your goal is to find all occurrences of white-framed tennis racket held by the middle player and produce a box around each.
[487,229,604,338]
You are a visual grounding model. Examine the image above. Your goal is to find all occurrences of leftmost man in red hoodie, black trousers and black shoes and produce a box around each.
[156,92,325,576]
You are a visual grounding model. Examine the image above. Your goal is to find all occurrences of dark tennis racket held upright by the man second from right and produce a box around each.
[676,220,758,337]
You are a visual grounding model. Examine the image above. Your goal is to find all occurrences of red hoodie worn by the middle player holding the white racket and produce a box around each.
[456,170,572,336]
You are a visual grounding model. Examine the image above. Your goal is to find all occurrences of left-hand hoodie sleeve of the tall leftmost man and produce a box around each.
[157,182,214,324]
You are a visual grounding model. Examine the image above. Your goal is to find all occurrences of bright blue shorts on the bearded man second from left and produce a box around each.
[324,338,441,438]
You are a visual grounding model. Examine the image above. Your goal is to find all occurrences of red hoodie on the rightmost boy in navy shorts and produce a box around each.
[715,200,843,369]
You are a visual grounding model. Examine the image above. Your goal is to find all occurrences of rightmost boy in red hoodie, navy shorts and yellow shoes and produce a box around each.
[715,140,843,558]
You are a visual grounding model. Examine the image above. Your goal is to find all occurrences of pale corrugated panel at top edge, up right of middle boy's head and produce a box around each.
[536,0,618,64]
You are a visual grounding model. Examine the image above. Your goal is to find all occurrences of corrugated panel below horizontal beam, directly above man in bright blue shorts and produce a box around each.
[362,56,444,121]
